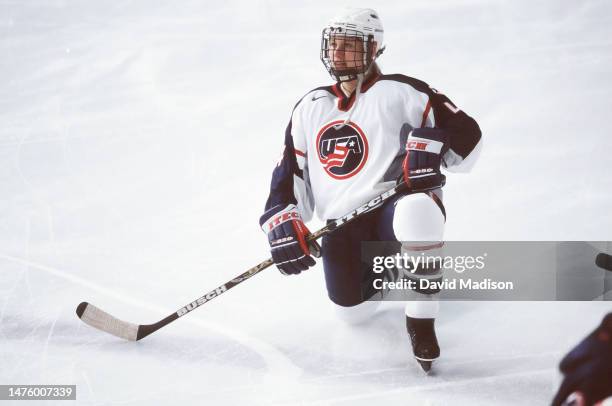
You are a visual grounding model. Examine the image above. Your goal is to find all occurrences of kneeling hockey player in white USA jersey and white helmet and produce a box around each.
[260,9,481,371]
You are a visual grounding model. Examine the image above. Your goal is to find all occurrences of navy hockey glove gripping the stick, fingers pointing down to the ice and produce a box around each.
[259,204,321,275]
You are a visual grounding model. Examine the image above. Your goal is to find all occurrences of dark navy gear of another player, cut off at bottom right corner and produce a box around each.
[552,313,612,406]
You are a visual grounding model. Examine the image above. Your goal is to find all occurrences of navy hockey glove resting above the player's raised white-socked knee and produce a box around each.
[399,128,449,192]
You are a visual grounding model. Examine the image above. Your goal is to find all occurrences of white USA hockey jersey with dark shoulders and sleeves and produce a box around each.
[266,72,481,221]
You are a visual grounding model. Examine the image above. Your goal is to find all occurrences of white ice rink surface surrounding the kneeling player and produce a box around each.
[0,0,612,405]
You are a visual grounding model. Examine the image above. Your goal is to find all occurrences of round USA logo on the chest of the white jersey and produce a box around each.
[317,120,368,179]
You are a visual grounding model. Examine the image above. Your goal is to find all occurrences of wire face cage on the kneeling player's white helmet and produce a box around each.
[321,27,374,82]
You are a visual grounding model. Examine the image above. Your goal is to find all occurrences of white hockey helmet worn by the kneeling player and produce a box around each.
[321,8,385,82]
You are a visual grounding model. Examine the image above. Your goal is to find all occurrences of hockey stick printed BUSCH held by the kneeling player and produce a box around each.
[76,182,407,341]
